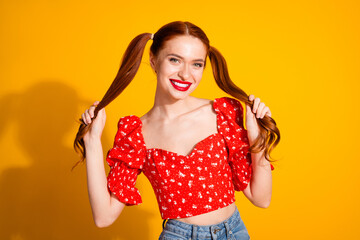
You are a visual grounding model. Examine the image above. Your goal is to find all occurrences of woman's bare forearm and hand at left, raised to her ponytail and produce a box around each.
[83,102,125,227]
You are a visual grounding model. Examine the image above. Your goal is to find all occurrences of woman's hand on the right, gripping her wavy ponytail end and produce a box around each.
[245,95,271,145]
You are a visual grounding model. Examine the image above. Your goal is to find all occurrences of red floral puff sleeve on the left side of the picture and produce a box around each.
[106,115,146,206]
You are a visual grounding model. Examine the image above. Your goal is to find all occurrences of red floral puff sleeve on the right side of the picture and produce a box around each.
[214,97,273,191]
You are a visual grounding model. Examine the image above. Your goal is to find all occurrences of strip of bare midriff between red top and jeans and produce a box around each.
[175,203,236,226]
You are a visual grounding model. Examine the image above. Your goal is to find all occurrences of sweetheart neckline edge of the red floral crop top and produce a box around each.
[134,98,221,158]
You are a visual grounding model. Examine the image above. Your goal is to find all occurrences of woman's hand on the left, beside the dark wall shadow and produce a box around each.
[81,101,106,143]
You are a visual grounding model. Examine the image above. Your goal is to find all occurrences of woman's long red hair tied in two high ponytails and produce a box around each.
[74,21,280,166]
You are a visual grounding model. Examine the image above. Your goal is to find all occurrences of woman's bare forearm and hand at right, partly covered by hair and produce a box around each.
[243,95,272,208]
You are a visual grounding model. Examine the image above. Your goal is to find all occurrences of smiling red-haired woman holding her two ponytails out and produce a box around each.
[74,21,280,239]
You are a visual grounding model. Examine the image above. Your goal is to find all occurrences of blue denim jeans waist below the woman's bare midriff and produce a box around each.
[159,207,250,240]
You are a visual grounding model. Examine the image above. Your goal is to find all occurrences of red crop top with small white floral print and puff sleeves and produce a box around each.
[106,97,273,219]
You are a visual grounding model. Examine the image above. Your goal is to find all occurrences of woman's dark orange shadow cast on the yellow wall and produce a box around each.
[0,80,152,240]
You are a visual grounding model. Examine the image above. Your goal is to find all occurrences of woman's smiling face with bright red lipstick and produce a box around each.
[150,36,206,99]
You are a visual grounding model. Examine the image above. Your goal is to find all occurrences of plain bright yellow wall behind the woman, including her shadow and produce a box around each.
[0,0,360,240]
